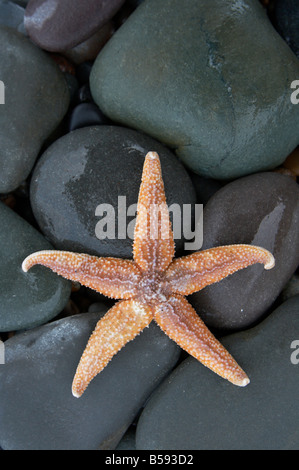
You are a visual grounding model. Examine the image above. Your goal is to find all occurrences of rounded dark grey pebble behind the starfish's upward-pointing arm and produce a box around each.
[31,126,195,258]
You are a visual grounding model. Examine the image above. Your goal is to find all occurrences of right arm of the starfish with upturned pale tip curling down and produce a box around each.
[166,245,275,295]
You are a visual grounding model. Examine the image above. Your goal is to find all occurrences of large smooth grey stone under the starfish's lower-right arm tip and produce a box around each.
[136,296,299,450]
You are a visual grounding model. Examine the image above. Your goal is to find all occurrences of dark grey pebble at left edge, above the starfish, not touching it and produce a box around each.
[0,26,69,193]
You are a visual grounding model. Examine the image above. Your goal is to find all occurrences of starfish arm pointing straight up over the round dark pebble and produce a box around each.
[133,152,174,272]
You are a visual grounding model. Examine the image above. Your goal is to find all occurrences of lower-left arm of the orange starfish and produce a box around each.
[72,299,153,398]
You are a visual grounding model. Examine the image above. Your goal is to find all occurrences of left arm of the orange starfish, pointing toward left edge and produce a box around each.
[22,250,141,299]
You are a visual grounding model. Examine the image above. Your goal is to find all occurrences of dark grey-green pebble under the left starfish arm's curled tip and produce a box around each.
[0,203,70,331]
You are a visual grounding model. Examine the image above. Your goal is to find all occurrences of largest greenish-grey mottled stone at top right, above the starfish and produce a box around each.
[91,0,299,179]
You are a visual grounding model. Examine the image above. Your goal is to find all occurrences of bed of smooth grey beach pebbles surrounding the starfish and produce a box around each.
[0,0,299,451]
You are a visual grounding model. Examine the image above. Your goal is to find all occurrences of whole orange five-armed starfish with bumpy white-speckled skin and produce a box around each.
[22,152,274,397]
